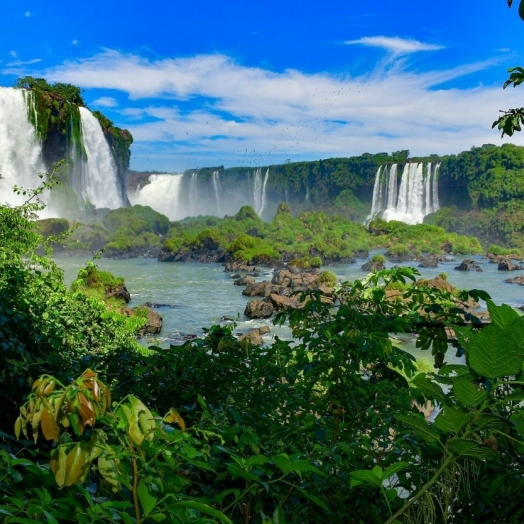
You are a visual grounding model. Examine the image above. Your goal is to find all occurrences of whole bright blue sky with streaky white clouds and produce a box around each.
[0,0,524,172]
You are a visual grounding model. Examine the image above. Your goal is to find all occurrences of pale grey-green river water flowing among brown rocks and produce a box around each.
[56,257,524,354]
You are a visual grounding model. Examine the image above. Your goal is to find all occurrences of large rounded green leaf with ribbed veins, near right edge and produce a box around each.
[466,325,523,378]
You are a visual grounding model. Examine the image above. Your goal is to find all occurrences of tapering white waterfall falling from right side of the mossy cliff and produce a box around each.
[77,107,125,209]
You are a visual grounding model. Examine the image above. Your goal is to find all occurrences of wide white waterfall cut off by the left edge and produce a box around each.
[0,88,46,205]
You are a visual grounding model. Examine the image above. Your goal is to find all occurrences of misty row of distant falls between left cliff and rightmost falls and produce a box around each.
[129,169,269,220]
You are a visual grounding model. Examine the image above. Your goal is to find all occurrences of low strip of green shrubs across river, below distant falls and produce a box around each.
[38,203,485,264]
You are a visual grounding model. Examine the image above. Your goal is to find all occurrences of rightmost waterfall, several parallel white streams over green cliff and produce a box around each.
[368,162,440,224]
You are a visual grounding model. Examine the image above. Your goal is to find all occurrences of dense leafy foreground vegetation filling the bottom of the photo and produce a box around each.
[0,169,524,524]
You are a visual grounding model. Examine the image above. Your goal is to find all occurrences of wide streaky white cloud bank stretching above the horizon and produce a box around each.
[40,50,522,169]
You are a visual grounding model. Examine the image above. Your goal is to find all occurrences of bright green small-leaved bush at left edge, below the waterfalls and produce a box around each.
[0,179,143,431]
